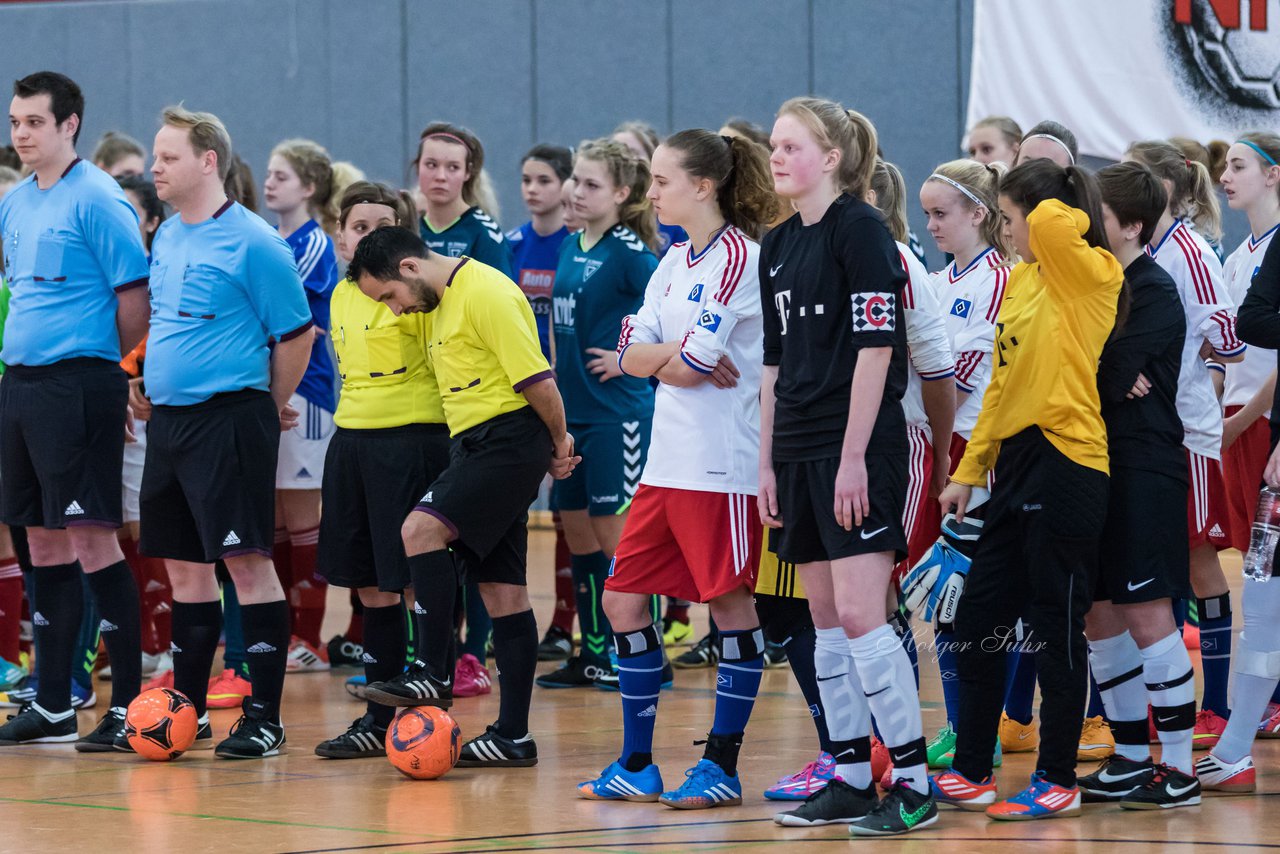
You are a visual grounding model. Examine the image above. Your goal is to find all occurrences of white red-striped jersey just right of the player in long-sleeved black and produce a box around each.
[1147,219,1244,460]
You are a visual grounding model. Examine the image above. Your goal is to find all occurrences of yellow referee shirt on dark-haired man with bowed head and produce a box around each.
[429,256,552,435]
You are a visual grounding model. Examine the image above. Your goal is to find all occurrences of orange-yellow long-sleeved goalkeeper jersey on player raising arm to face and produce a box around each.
[952,198,1124,487]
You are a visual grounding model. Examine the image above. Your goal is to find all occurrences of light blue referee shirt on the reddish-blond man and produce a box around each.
[143,201,311,406]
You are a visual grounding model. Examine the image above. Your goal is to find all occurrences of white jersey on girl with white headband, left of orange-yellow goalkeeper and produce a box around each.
[933,246,1009,439]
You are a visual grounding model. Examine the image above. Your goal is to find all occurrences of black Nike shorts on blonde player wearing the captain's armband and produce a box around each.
[773,455,908,563]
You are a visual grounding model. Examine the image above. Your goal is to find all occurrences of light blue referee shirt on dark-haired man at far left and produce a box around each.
[0,160,147,365]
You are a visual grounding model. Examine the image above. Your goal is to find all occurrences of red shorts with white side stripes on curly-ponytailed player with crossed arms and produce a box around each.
[604,484,764,602]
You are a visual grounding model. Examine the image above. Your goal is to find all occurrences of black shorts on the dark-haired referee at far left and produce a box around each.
[0,359,129,529]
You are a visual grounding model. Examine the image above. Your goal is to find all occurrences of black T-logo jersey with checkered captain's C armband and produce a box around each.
[760,195,908,462]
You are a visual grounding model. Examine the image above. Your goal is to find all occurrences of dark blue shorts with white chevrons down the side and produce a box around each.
[552,417,653,516]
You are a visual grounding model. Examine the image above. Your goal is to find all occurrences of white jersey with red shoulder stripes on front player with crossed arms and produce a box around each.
[618,227,764,495]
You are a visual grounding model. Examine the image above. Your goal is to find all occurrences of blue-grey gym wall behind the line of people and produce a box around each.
[0,0,1239,261]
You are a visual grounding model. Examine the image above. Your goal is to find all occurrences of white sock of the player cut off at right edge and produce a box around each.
[1213,579,1280,763]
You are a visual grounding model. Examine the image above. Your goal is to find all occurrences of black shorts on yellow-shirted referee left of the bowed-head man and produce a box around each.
[316,424,449,593]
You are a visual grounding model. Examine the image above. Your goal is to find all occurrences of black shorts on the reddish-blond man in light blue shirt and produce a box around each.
[138,389,280,563]
